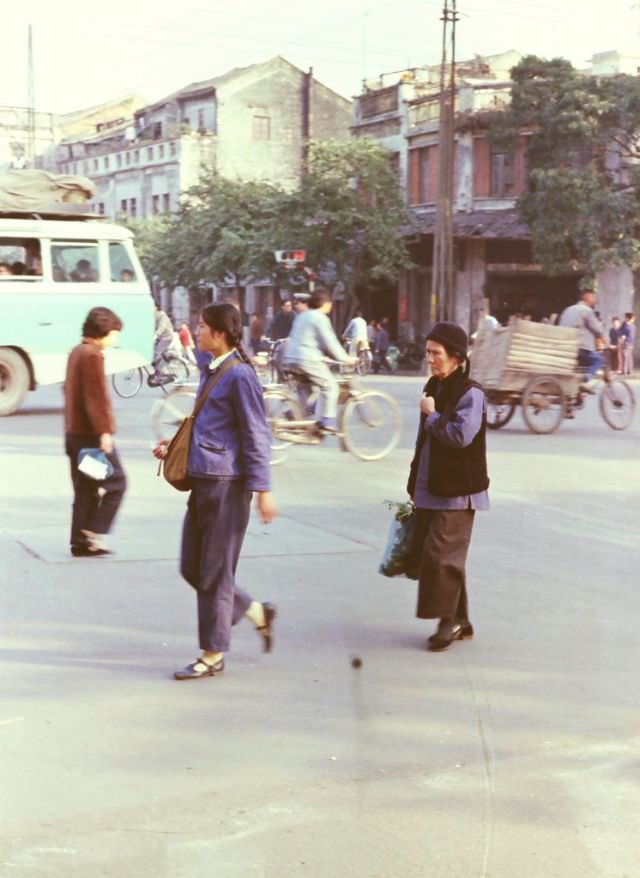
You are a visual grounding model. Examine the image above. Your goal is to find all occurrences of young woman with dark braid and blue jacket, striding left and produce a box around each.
[153,305,277,680]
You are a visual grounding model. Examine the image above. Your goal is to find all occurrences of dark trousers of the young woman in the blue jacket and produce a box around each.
[180,479,252,652]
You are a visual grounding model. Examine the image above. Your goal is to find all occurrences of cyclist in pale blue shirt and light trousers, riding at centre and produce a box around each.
[285,287,358,434]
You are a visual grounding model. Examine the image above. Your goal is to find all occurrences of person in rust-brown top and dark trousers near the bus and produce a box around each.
[64,308,126,558]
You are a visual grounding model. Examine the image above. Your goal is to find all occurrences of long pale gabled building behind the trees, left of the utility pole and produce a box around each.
[58,57,351,219]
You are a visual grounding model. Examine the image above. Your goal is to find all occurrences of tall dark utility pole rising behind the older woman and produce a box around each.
[430,0,458,324]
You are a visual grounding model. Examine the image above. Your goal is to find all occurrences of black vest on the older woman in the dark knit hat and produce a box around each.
[407,369,489,497]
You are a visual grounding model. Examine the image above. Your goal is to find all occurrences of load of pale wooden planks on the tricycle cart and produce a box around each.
[471,317,578,392]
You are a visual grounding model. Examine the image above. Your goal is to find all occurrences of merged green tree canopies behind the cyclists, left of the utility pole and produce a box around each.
[127,140,409,298]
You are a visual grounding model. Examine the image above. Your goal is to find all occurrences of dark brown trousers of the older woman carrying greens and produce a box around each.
[415,509,475,621]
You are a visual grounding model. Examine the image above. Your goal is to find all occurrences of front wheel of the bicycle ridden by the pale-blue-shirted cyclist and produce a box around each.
[340,390,402,460]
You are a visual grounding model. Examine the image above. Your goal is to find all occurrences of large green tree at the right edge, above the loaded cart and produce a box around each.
[489,56,640,274]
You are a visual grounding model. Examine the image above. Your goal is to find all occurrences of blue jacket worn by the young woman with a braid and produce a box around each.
[189,352,271,491]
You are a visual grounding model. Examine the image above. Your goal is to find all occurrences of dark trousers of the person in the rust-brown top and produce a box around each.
[65,433,127,546]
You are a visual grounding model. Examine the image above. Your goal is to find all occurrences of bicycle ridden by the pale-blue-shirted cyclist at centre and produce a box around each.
[264,372,402,463]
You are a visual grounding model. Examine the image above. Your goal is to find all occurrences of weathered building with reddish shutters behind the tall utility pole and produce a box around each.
[352,52,633,344]
